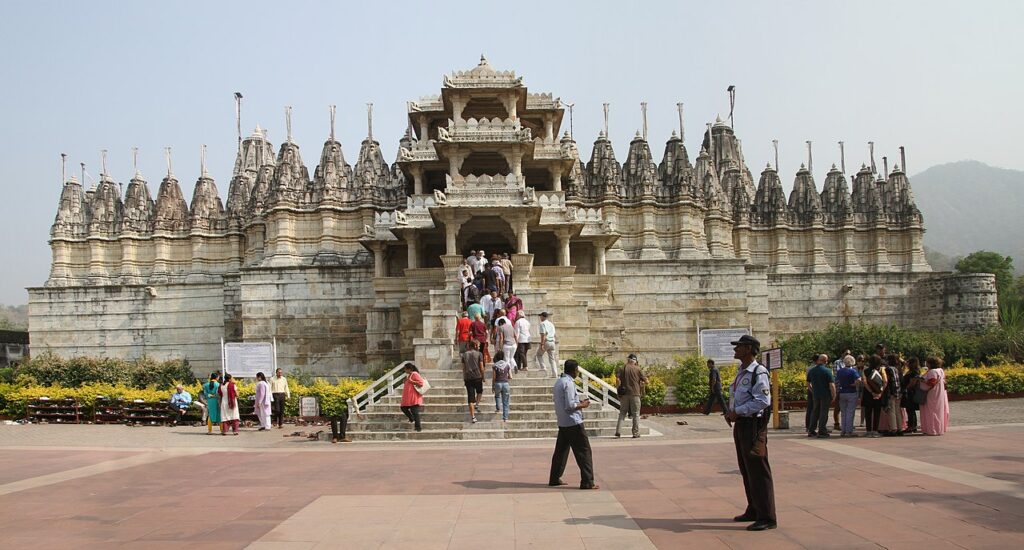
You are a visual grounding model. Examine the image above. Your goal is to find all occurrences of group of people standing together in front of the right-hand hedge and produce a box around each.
[805,344,949,438]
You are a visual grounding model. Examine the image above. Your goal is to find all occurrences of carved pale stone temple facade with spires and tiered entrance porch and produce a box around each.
[30,58,995,375]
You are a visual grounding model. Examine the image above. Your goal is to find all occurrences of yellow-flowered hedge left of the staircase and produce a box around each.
[0,378,370,418]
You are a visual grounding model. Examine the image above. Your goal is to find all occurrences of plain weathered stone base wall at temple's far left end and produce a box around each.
[29,283,225,373]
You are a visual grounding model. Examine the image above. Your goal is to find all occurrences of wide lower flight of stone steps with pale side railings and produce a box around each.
[348,369,649,440]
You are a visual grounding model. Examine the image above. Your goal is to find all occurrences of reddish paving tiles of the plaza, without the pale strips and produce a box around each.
[0,428,1024,550]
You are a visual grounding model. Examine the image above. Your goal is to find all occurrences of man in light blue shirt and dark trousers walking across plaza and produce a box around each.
[548,359,600,489]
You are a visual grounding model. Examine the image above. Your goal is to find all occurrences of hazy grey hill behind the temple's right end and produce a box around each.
[910,161,1024,272]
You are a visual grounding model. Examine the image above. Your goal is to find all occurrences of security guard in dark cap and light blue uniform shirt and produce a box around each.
[725,334,778,531]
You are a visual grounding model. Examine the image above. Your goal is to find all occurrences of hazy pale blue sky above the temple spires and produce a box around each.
[0,0,1024,304]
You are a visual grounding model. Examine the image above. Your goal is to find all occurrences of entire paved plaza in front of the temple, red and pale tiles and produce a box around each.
[0,399,1024,550]
